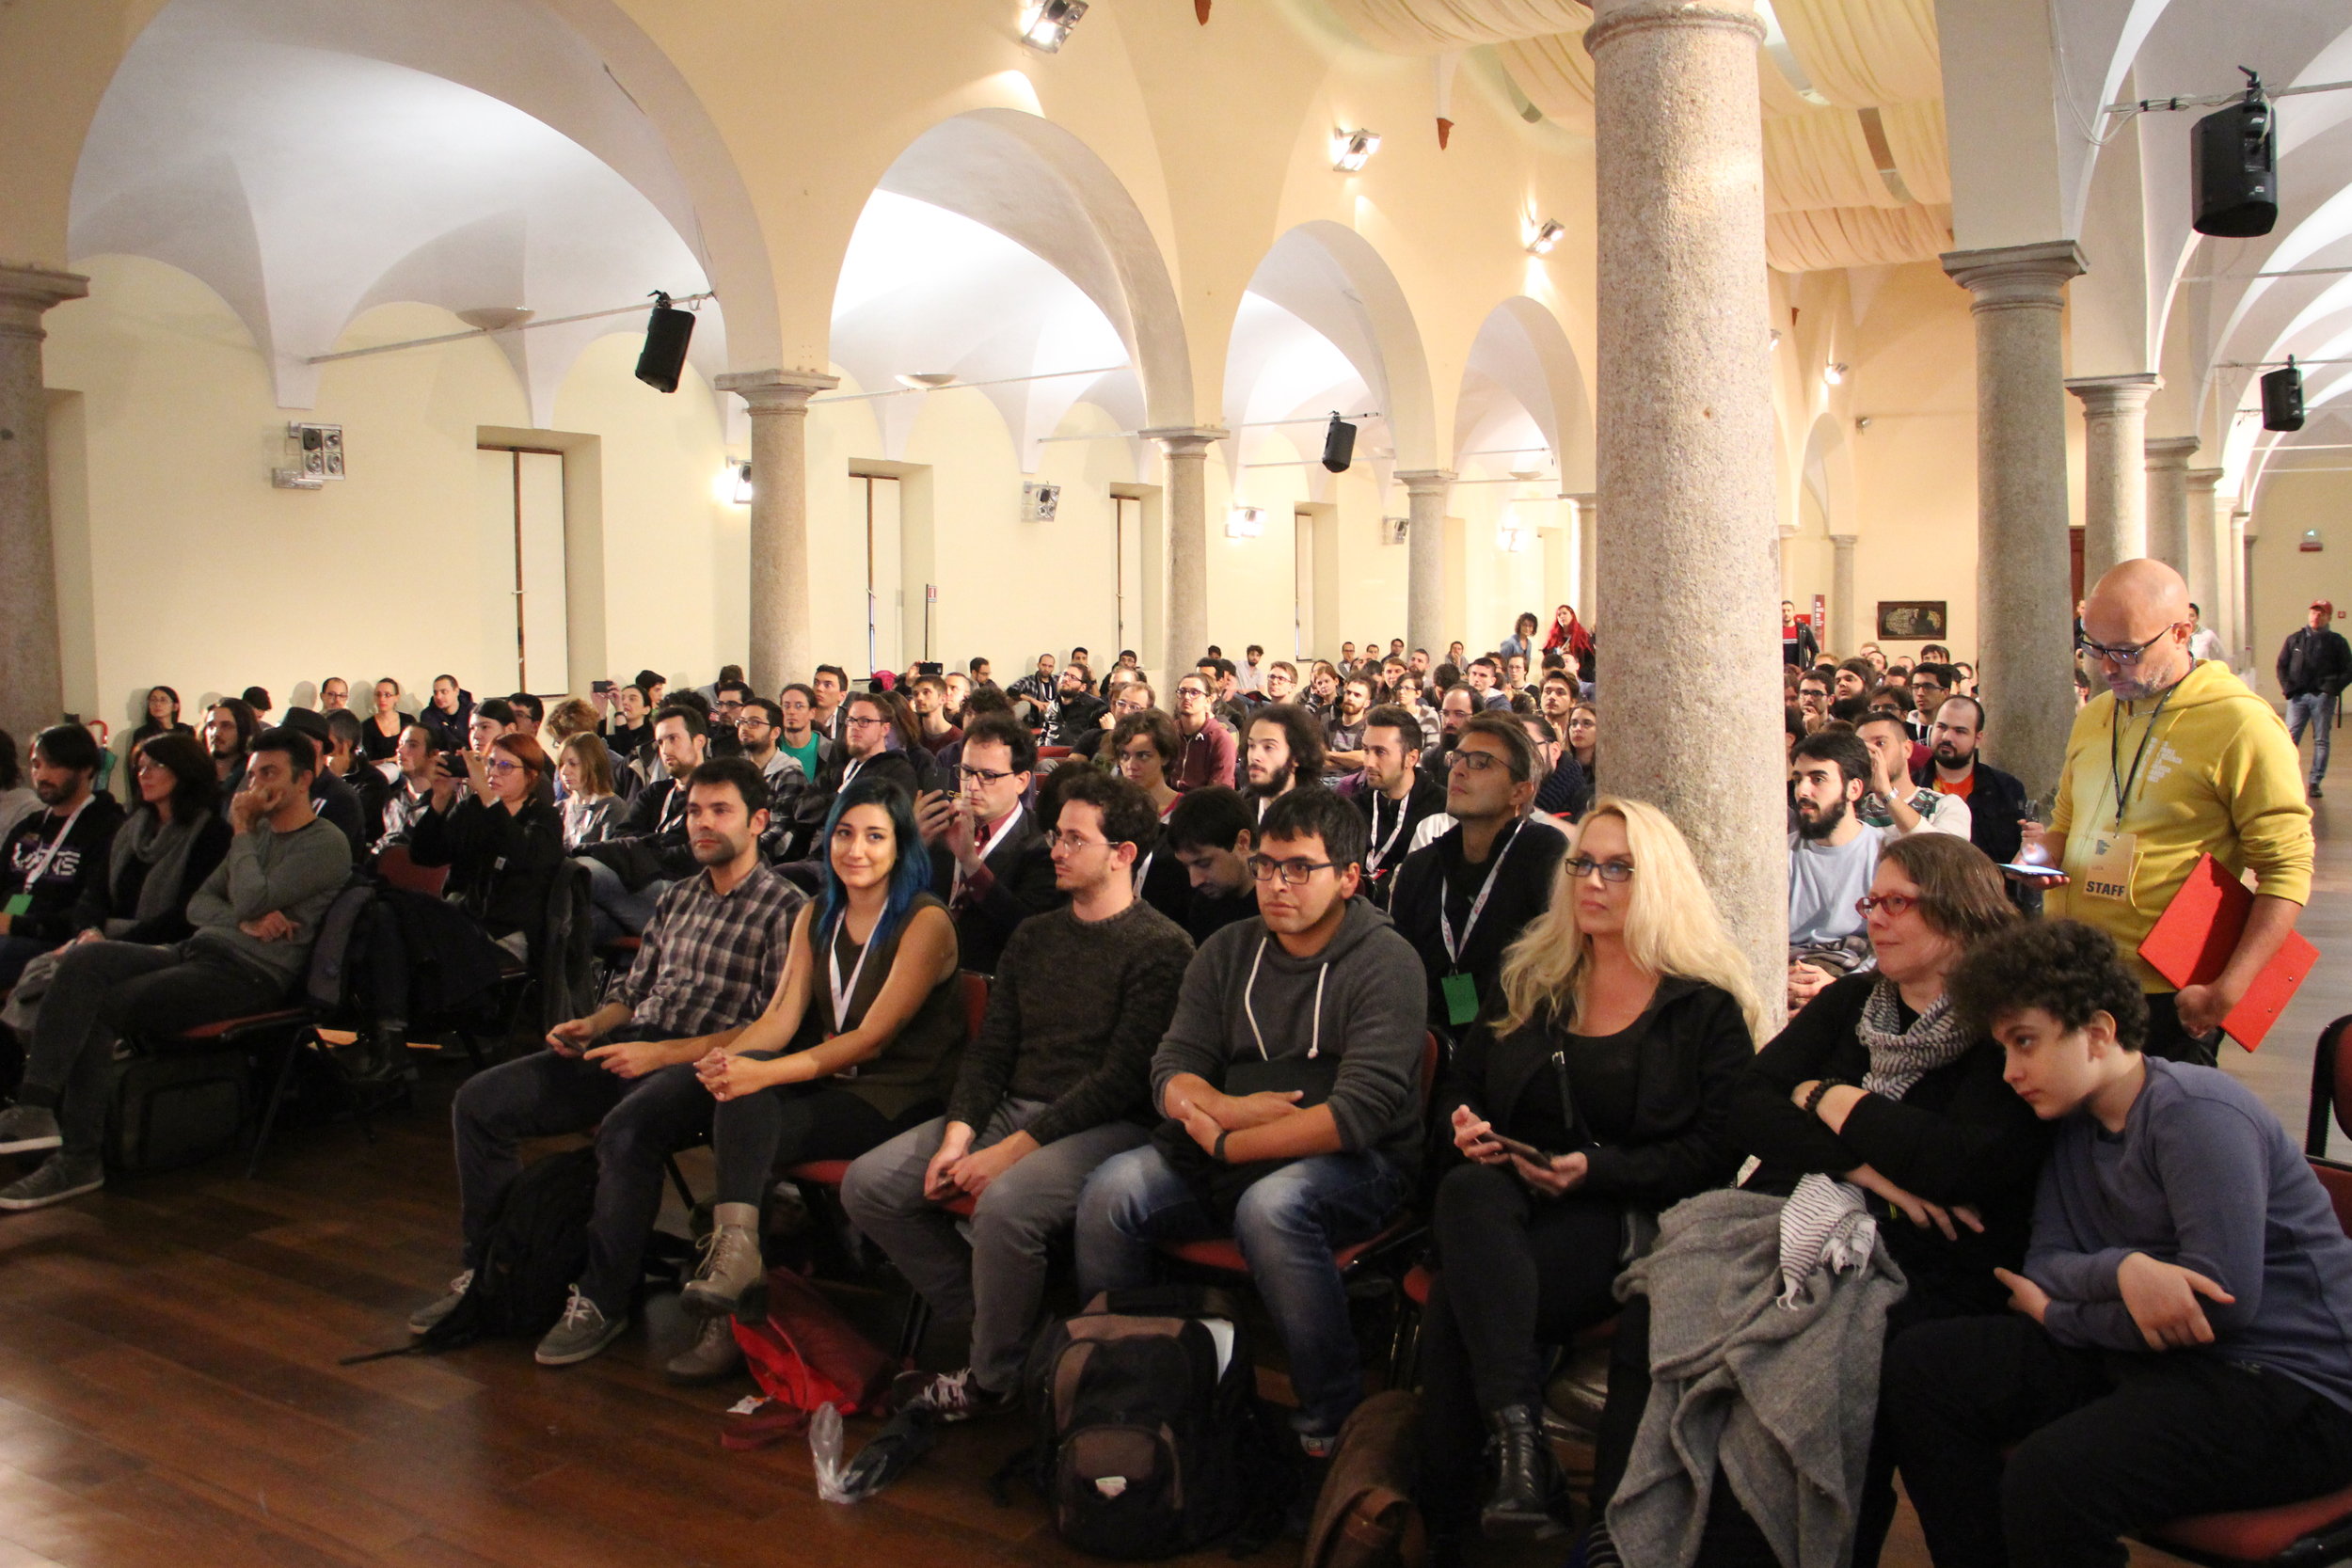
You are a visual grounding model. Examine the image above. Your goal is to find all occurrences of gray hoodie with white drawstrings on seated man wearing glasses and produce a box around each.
[1152,898,1428,1173]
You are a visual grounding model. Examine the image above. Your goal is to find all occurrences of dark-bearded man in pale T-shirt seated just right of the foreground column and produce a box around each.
[1788,729,1891,1013]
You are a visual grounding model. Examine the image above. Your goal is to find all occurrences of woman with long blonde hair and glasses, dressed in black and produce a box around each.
[1421,797,1764,1538]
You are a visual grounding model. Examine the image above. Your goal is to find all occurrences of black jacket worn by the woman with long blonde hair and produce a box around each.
[1438,975,1755,1209]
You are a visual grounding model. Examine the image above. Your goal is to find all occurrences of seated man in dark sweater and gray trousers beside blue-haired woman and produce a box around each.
[842,768,1193,1420]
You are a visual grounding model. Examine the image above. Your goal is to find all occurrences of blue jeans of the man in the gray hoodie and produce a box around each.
[1077,1145,1406,1439]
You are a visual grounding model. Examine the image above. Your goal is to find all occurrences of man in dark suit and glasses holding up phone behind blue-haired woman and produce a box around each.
[915,712,1066,975]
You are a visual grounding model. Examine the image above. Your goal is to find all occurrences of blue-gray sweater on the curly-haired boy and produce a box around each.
[2026,1055,2352,1408]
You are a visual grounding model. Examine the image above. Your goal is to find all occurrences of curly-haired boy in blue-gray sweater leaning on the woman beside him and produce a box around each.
[1882,922,2352,1568]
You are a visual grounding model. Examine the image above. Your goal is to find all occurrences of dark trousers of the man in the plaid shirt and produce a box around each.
[450,1048,713,1317]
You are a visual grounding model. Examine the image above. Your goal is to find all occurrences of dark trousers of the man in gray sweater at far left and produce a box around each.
[24,942,287,1157]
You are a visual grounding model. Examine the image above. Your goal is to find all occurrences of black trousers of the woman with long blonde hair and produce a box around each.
[1421,1164,1626,1524]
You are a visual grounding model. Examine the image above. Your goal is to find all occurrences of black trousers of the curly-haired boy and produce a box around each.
[1882,1314,2352,1568]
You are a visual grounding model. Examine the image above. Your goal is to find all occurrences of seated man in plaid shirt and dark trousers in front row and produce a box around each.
[409,757,807,1380]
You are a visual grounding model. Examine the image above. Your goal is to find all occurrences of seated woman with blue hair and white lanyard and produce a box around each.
[682,780,964,1317]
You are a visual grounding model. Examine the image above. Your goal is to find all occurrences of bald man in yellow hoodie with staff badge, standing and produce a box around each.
[2023,560,2312,1065]
